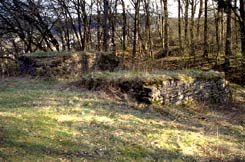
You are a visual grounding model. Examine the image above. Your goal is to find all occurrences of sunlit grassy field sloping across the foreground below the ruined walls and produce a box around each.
[0,78,245,162]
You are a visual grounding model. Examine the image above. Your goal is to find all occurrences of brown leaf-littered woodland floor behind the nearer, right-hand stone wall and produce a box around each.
[133,51,245,85]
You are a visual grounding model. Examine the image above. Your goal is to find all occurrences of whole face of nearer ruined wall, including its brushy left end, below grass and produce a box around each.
[81,72,231,105]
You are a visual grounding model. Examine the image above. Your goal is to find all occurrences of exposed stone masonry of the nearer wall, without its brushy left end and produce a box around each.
[129,80,231,105]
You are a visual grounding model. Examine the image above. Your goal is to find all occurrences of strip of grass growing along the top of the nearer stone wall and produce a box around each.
[84,69,224,84]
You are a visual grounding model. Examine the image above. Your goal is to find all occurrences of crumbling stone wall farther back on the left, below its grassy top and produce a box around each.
[18,52,119,78]
